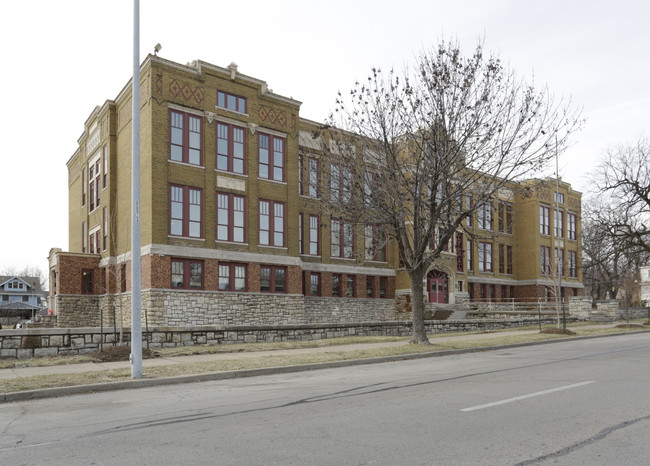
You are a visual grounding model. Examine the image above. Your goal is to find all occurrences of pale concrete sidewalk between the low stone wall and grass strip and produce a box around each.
[0,324,613,380]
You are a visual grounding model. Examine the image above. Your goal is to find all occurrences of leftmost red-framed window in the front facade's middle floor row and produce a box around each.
[169,185,203,238]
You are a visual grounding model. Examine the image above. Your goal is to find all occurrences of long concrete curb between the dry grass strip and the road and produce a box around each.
[0,330,650,403]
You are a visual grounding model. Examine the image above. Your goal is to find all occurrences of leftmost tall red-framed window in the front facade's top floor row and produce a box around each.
[169,110,203,165]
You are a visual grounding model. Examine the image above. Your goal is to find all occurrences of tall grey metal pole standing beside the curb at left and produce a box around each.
[130,0,142,379]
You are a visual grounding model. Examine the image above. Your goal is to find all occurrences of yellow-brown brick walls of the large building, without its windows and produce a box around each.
[48,56,582,324]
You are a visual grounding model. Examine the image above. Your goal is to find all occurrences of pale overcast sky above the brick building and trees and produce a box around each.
[0,0,650,271]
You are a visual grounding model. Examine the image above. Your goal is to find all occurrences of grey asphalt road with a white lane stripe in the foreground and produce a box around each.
[0,333,650,465]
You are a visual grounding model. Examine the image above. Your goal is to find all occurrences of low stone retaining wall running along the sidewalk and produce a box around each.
[0,319,556,359]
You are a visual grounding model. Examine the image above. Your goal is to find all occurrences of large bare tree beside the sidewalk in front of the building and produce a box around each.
[322,41,581,343]
